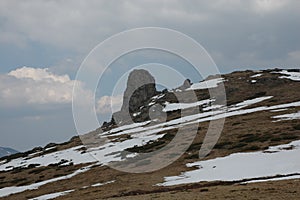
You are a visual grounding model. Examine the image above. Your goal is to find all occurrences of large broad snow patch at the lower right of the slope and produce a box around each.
[157,140,300,186]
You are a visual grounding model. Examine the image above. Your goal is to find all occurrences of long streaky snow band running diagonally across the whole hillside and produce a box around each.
[0,96,300,171]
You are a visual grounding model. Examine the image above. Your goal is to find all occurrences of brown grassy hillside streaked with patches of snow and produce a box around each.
[0,69,300,200]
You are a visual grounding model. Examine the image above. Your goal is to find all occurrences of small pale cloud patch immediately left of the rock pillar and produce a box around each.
[96,95,123,114]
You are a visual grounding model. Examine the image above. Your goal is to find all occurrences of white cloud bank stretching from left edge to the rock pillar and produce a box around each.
[0,67,123,114]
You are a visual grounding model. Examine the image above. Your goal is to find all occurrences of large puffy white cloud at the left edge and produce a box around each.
[0,67,92,107]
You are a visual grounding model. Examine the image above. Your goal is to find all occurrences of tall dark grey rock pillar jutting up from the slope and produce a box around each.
[113,69,158,123]
